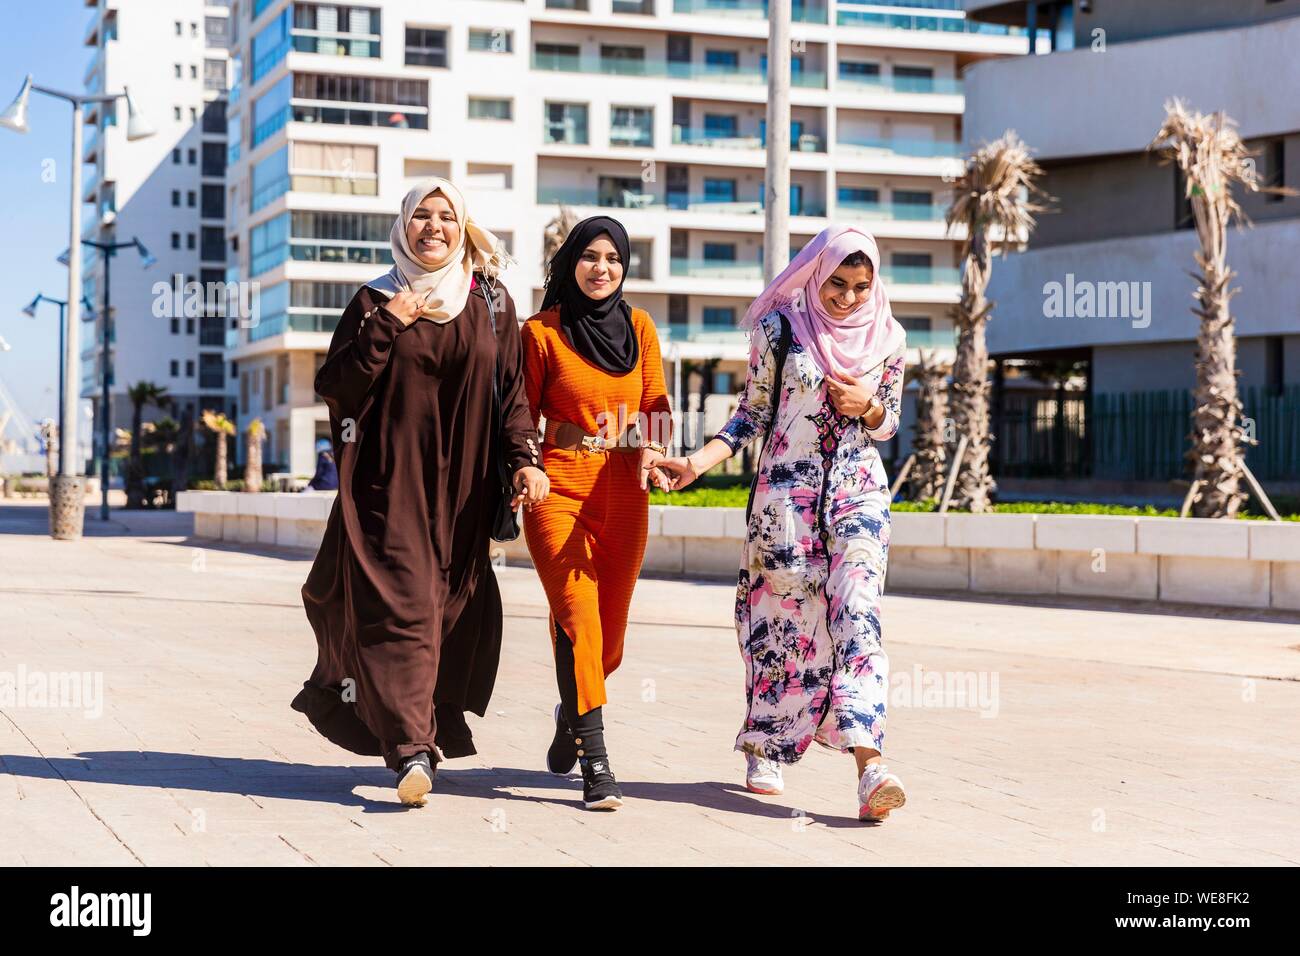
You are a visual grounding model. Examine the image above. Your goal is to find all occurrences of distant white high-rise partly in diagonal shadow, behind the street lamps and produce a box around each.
[73,0,231,450]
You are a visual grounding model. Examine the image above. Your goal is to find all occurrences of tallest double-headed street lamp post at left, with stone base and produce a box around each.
[0,74,153,540]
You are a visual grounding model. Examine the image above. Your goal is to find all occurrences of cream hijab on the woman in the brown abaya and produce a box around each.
[367,177,514,323]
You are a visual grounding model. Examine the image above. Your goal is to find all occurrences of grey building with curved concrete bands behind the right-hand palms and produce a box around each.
[965,0,1300,486]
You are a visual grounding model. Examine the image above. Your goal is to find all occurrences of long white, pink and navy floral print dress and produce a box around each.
[716,311,906,763]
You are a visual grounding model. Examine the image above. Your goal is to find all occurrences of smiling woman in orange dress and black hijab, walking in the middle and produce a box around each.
[523,216,672,810]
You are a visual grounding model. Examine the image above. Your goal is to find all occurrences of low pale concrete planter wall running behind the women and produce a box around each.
[177,492,1300,610]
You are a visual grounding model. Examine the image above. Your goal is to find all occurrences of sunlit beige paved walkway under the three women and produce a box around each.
[0,502,1300,866]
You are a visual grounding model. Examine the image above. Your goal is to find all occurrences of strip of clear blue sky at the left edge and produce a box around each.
[0,0,95,421]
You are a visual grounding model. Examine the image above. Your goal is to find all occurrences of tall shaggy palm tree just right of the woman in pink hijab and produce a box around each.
[945,130,1047,512]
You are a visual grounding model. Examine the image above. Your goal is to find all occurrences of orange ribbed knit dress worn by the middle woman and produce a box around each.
[521,306,670,714]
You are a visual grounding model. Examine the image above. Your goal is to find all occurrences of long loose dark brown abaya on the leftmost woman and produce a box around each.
[293,277,537,770]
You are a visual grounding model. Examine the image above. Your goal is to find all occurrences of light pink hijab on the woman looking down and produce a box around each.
[741,225,906,378]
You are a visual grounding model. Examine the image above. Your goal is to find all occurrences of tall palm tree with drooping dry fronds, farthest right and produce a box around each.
[1147,99,1294,518]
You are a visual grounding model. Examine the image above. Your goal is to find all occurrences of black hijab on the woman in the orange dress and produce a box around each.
[542,216,641,375]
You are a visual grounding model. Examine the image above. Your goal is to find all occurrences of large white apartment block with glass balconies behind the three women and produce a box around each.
[226,0,1028,475]
